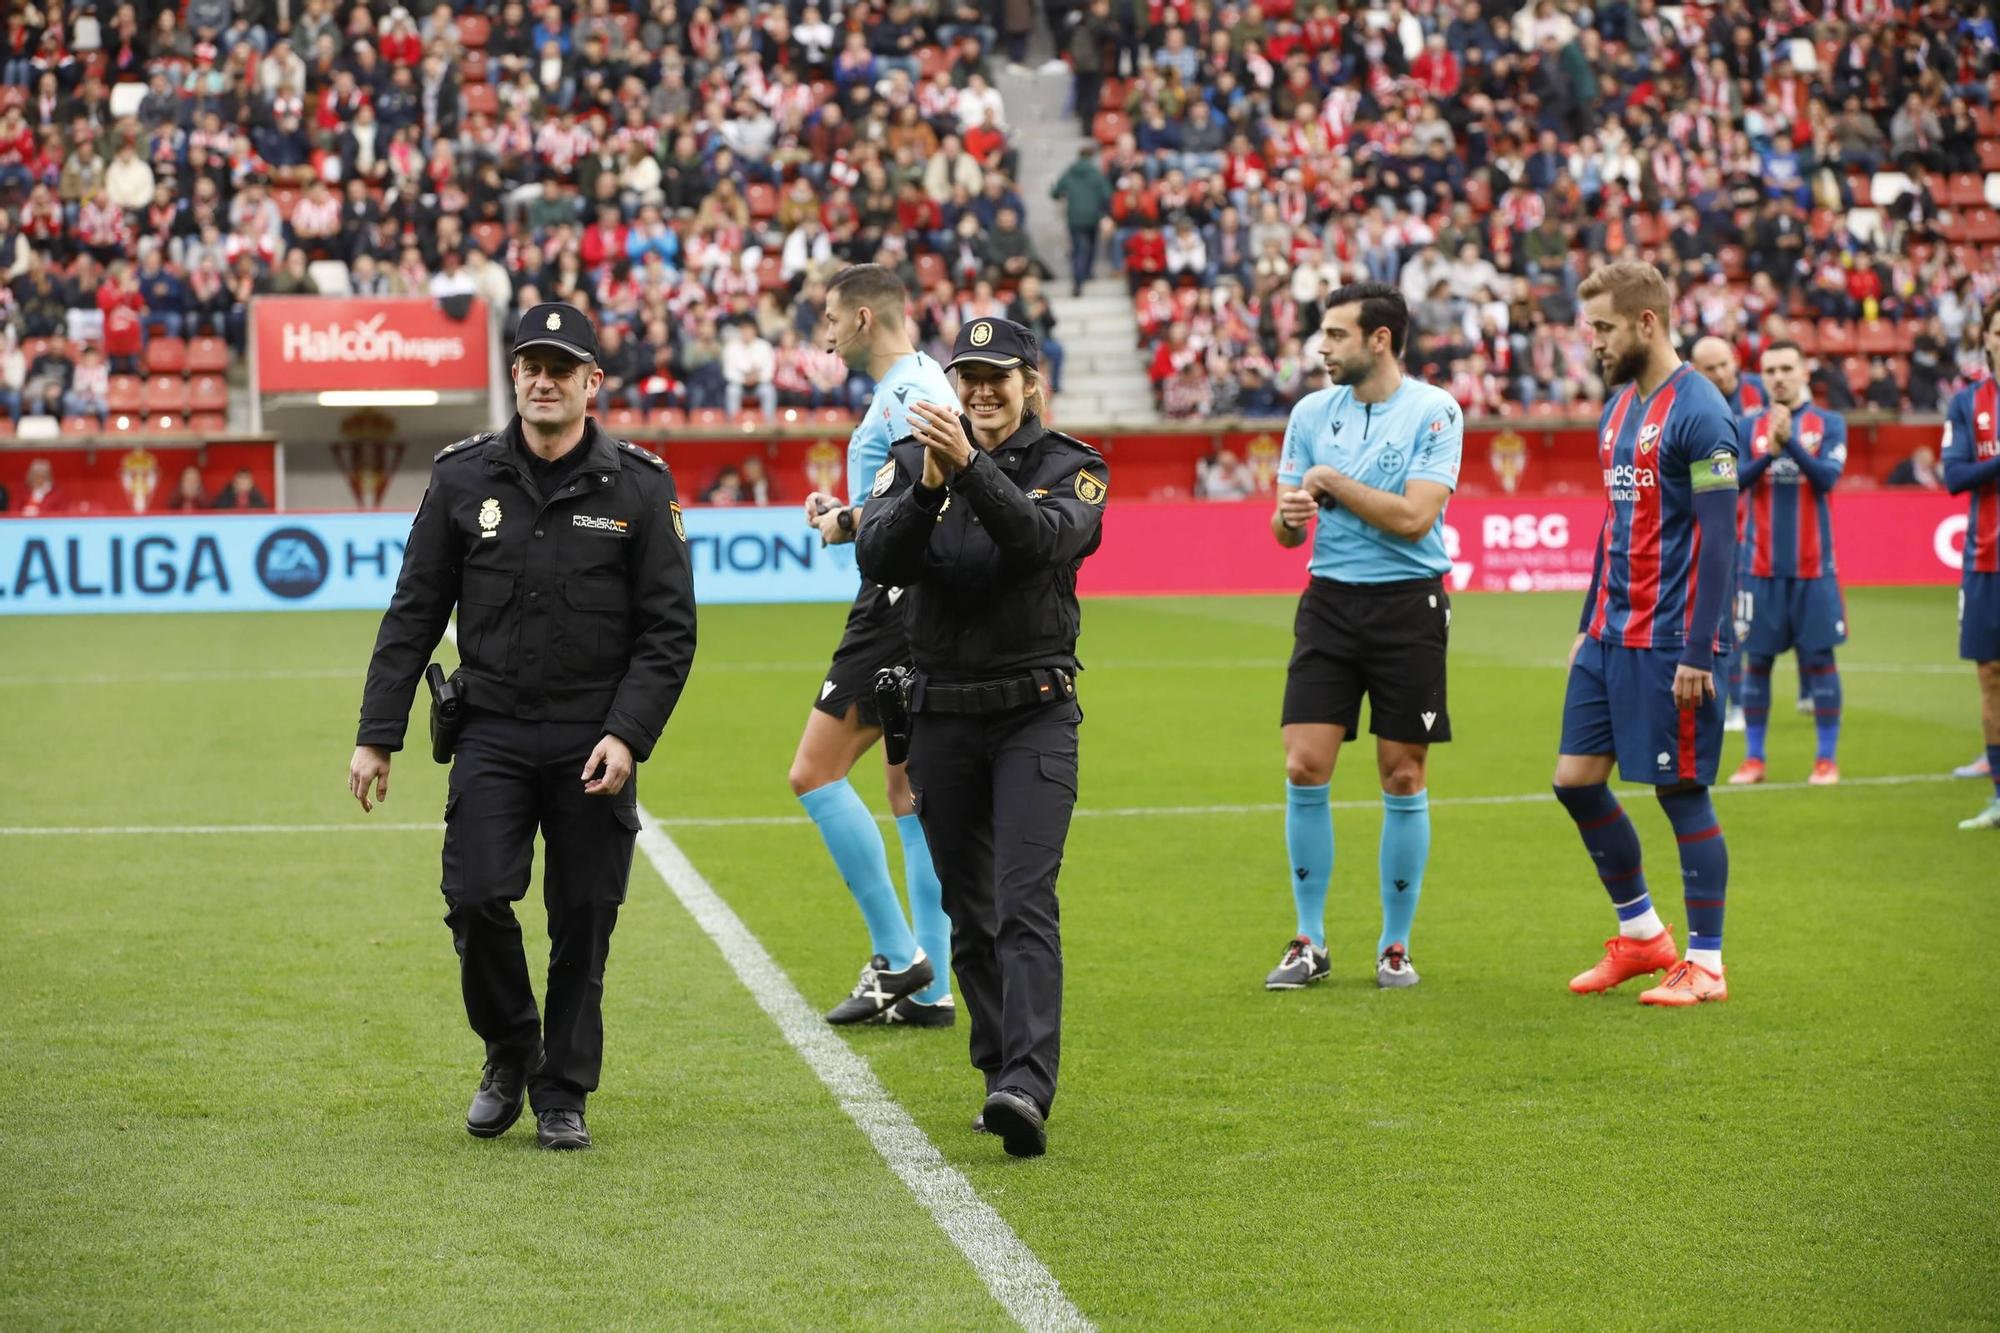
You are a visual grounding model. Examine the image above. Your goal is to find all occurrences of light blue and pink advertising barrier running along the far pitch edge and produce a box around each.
[0,488,1966,614]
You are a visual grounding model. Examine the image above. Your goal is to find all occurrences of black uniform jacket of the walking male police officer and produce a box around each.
[358,416,694,761]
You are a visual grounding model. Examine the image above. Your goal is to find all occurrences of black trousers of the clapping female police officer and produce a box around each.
[910,699,1084,1115]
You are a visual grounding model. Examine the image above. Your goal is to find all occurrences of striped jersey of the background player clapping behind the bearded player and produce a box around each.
[1736,402,1848,578]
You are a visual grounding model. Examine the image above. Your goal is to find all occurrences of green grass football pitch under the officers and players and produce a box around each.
[0,588,2000,1329]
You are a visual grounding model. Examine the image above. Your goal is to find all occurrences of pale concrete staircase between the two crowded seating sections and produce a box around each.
[994,50,1160,428]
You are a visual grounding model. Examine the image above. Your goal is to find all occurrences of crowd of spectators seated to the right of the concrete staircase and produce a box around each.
[1054,0,2000,416]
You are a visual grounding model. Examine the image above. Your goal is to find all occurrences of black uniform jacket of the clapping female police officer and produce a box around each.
[854,414,1110,683]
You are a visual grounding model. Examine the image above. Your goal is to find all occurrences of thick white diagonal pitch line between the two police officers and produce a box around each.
[638,811,1092,1331]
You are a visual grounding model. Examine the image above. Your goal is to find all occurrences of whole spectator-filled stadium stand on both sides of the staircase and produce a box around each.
[0,0,2000,430]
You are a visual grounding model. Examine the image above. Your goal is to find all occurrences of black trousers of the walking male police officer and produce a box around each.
[444,711,638,1111]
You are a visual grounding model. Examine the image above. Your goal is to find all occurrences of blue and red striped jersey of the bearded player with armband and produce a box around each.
[1586,364,1738,652]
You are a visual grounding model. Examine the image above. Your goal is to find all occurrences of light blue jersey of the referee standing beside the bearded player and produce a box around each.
[1278,374,1466,582]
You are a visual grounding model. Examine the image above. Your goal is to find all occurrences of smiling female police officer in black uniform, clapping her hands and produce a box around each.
[856,318,1110,1157]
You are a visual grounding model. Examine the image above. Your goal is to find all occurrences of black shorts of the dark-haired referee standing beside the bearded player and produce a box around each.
[1284,578,1452,745]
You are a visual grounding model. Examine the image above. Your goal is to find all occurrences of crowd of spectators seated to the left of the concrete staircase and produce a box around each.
[0,0,1062,426]
